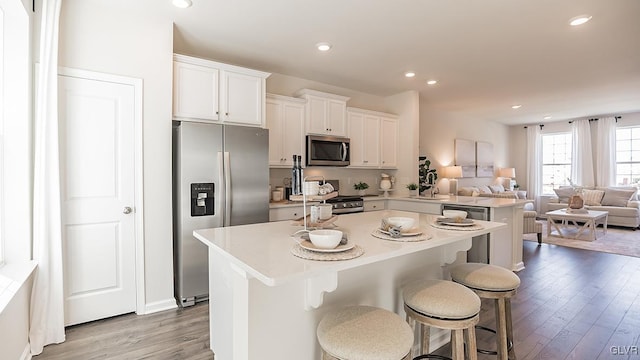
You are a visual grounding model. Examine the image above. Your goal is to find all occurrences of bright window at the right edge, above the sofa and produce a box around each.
[616,126,640,187]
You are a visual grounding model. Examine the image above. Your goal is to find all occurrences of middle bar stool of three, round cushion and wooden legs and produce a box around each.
[402,280,480,360]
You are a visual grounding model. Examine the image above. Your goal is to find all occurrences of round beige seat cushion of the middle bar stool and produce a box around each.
[402,280,480,319]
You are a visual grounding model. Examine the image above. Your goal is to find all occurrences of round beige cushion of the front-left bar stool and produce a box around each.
[317,306,413,360]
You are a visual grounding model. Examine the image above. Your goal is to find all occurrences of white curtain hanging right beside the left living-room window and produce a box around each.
[571,119,595,187]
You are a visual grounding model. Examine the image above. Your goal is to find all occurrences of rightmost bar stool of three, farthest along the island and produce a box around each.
[449,263,520,360]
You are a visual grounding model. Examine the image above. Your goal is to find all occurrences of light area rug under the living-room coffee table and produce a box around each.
[523,221,640,257]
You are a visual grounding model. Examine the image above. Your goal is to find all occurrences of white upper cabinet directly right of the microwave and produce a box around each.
[347,108,398,169]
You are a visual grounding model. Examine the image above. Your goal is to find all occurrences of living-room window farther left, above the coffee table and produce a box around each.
[542,132,571,194]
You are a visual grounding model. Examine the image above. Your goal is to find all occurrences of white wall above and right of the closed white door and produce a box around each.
[59,0,175,308]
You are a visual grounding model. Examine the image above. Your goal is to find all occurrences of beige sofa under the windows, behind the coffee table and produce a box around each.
[547,187,640,230]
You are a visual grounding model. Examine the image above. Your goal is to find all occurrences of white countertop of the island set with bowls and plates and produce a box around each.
[194,208,508,286]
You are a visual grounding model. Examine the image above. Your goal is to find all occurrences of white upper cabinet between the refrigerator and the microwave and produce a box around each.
[266,94,305,167]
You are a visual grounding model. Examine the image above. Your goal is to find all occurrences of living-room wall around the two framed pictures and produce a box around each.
[419,98,510,193]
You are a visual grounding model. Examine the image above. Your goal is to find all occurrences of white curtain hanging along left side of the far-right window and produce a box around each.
[596,116,616,187]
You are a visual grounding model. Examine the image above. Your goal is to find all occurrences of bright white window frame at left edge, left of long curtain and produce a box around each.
[0,0,33,265]
